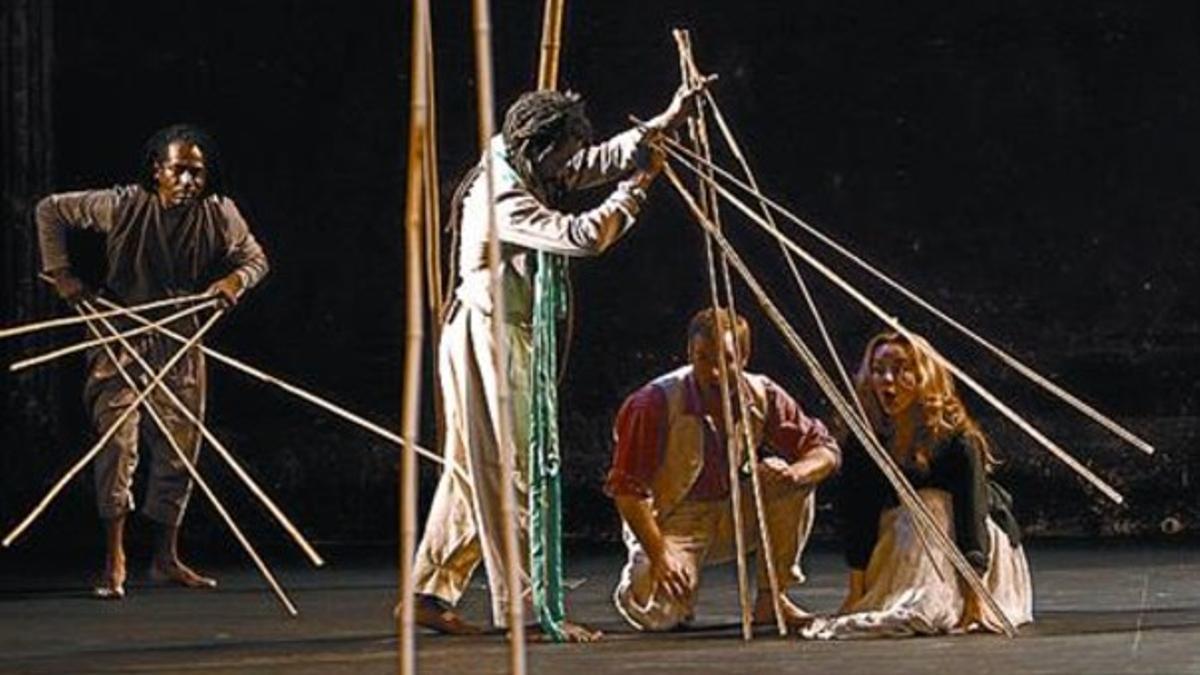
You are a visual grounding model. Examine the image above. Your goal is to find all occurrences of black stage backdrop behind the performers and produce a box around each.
[0,0,1200,557]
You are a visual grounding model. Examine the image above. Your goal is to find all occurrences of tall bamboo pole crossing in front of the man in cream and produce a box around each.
[473,0,526,662]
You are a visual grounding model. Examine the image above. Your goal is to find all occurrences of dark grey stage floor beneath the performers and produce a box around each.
[0,543,1200,675]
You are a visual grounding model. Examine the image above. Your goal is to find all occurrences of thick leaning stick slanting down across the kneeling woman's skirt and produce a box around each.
[665,165,1016,637]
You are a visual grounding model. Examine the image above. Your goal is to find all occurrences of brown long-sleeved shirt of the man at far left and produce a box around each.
[36,185,269,304]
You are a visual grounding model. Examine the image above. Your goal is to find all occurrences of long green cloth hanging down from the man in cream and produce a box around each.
[527,252,568,643]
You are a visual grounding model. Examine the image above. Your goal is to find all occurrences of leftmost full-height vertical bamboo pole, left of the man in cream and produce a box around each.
[396,0,430,675]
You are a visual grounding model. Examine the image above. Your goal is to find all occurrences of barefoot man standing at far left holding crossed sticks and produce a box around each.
[36,125,268,599]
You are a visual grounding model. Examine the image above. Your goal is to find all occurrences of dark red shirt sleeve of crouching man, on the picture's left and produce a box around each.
[604,384,667,498]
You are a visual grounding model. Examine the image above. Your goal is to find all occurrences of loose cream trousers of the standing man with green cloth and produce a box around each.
[413,305,533,627]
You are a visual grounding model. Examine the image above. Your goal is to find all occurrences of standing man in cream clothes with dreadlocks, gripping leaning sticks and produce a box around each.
[413,81,700,641]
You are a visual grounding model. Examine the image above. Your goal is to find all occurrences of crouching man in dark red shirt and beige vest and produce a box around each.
[605,310,841,631]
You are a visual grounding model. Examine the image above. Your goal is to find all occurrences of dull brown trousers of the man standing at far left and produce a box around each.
[84,336,205,526]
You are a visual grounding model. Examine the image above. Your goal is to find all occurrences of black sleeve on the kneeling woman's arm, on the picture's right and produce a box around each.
[932,436,991,572]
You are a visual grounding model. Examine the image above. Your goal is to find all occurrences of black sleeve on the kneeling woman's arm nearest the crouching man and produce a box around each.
[838,442,890,569]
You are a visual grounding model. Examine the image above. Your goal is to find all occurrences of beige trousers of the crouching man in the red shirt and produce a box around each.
[613,483,815,631]
